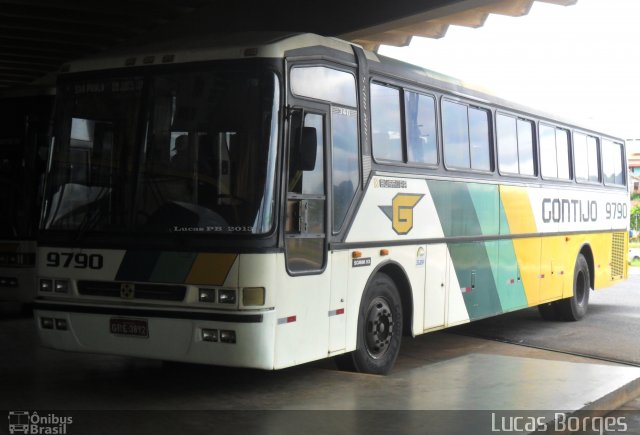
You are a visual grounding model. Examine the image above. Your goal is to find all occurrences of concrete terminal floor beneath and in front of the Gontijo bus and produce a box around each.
[0,276,640,434]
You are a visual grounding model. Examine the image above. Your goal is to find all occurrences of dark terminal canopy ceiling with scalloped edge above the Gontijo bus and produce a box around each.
[0,0,577,90]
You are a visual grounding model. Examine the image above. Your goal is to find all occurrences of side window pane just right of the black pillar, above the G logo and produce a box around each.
[371,83,403,161]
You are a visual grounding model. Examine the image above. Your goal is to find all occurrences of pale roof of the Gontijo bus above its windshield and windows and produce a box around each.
[61,32,614,138]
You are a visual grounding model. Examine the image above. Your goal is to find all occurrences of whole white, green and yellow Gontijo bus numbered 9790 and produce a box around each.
[35,34,629,373]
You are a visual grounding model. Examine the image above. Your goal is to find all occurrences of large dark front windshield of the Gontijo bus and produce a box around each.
[41,67,280,236]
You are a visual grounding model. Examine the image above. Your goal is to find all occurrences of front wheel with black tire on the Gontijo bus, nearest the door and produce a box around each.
[335,273,402,375]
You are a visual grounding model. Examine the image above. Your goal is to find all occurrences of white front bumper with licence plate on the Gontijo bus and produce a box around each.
[34,301,276,370]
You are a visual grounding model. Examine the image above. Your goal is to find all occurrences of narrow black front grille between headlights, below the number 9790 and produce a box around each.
[78,281,187,301]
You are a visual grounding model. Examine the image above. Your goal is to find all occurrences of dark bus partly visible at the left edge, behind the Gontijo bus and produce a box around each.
[0,88,54,307]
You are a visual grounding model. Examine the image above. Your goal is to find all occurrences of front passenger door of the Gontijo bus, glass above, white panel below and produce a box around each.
[276,101,332,367]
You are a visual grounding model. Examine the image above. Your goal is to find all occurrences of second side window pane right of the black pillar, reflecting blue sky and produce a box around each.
[404,91,438,165]
